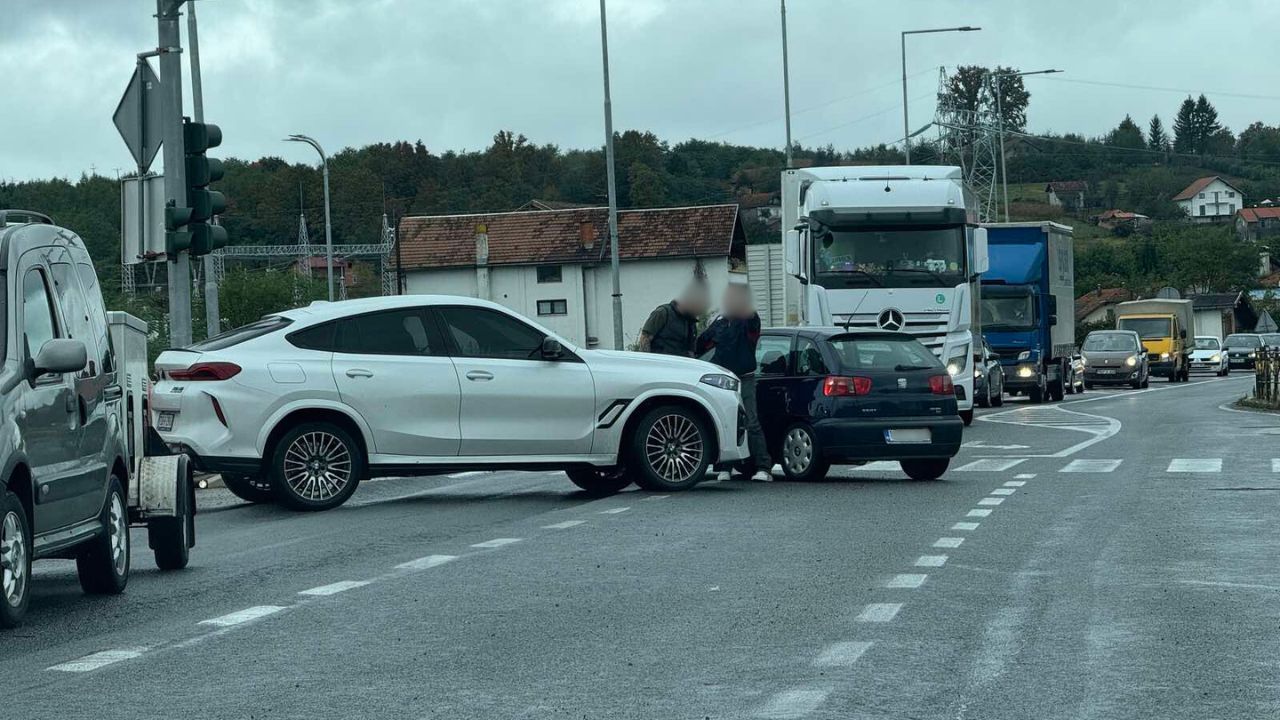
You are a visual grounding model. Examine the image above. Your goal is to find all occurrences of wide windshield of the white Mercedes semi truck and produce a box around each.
[812,224,965,287]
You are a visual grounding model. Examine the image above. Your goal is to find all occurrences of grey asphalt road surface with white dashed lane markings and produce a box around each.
[0,368,1280,720]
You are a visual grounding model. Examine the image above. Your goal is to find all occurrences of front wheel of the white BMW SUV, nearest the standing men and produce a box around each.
[627,405,713,492]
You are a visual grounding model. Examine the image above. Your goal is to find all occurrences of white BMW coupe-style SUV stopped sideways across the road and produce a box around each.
[151,295,746,510]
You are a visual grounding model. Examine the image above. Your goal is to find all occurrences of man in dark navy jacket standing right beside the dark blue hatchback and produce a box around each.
[696,283,773,483]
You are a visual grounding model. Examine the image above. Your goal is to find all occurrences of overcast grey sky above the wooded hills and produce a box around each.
[0,0,1280,179]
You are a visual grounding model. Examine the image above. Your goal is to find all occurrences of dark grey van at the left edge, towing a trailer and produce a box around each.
[0,210,192,628]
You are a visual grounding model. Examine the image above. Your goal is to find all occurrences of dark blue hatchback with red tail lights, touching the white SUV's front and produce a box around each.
[755,328,964,480]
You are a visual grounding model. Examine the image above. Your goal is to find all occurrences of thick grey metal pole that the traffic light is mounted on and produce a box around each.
[156,0,191,347]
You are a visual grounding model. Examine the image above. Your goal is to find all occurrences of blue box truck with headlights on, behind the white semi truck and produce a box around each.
[978,222,1075,402]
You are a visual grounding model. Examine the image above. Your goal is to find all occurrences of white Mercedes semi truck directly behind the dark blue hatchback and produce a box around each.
[782,165,987,424]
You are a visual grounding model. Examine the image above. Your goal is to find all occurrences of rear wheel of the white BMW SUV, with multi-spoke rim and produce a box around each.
[270,421,365,512]
